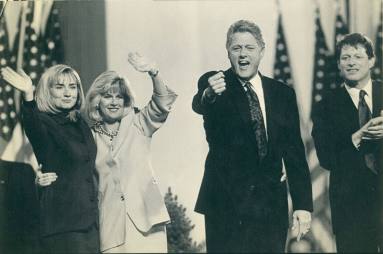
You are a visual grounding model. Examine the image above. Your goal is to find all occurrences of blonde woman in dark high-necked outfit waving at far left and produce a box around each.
[2,65,99,253]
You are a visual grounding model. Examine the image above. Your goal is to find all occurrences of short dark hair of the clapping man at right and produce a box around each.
[335,33,375,61]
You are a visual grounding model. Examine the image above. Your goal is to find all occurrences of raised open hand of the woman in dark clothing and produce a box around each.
[1,67,33,94]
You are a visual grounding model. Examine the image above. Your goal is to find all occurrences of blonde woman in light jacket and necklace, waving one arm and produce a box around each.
[85,53,177,252]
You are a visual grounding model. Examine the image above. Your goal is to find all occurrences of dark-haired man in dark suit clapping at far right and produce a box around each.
[312,33,383,252]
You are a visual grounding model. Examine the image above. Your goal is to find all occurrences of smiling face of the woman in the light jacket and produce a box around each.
[99,89,124,123]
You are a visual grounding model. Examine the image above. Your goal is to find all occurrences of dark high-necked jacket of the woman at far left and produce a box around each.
[22,101,98,236]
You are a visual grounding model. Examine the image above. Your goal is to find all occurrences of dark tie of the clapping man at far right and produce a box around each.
[358,90,378,174]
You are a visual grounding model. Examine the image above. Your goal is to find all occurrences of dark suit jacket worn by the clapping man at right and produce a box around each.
[312,82,383,234]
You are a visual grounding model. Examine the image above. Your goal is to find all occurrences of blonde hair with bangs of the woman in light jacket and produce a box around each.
[84,71,135,126]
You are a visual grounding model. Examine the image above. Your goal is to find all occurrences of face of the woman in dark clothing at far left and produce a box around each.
[49,75,78,110]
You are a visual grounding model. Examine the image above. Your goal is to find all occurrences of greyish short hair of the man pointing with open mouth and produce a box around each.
[226,20,265,49]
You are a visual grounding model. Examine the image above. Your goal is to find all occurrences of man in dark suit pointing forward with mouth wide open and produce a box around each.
[193,20,313,253]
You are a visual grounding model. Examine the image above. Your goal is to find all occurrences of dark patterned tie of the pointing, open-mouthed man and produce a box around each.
[244,82,267,160]
